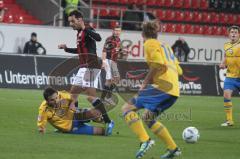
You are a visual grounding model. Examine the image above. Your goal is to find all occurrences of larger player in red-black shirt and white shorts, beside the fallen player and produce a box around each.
[58,10,114,135]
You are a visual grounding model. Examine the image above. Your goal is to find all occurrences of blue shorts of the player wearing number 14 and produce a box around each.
[131,85,178,113]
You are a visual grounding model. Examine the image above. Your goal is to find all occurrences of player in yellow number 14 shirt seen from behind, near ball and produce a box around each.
[122,21,182,158]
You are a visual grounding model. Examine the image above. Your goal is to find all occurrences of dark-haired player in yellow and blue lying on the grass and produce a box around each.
[37,87,112,135]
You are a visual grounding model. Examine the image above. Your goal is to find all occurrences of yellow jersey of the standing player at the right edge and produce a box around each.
[224,40,240,78]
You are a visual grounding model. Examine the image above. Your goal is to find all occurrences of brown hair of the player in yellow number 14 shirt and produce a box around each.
[142,21,160,39]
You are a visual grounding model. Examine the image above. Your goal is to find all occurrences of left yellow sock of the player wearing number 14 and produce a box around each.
[125,111,149,142]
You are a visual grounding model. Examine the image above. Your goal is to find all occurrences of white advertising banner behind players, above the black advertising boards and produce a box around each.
[0,24,227,63]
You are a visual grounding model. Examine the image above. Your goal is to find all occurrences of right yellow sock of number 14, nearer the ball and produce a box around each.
[150,121,177,150]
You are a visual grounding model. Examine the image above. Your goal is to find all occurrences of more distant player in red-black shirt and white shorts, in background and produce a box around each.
[101,26,121,101]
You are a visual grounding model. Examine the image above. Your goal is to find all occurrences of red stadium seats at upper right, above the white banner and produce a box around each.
[86,0,240,36]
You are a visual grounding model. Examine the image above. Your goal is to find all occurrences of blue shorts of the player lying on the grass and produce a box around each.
[69,120,94,135]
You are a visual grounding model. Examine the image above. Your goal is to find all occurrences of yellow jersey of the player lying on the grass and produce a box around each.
[37,91,75,132]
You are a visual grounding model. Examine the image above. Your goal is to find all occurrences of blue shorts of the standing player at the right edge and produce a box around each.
[224,77,240,91]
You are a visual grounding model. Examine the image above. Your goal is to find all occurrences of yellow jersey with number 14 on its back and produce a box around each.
[144,39,182,96]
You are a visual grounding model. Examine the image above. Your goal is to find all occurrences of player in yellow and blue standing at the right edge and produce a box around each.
[220,26,240,126]
